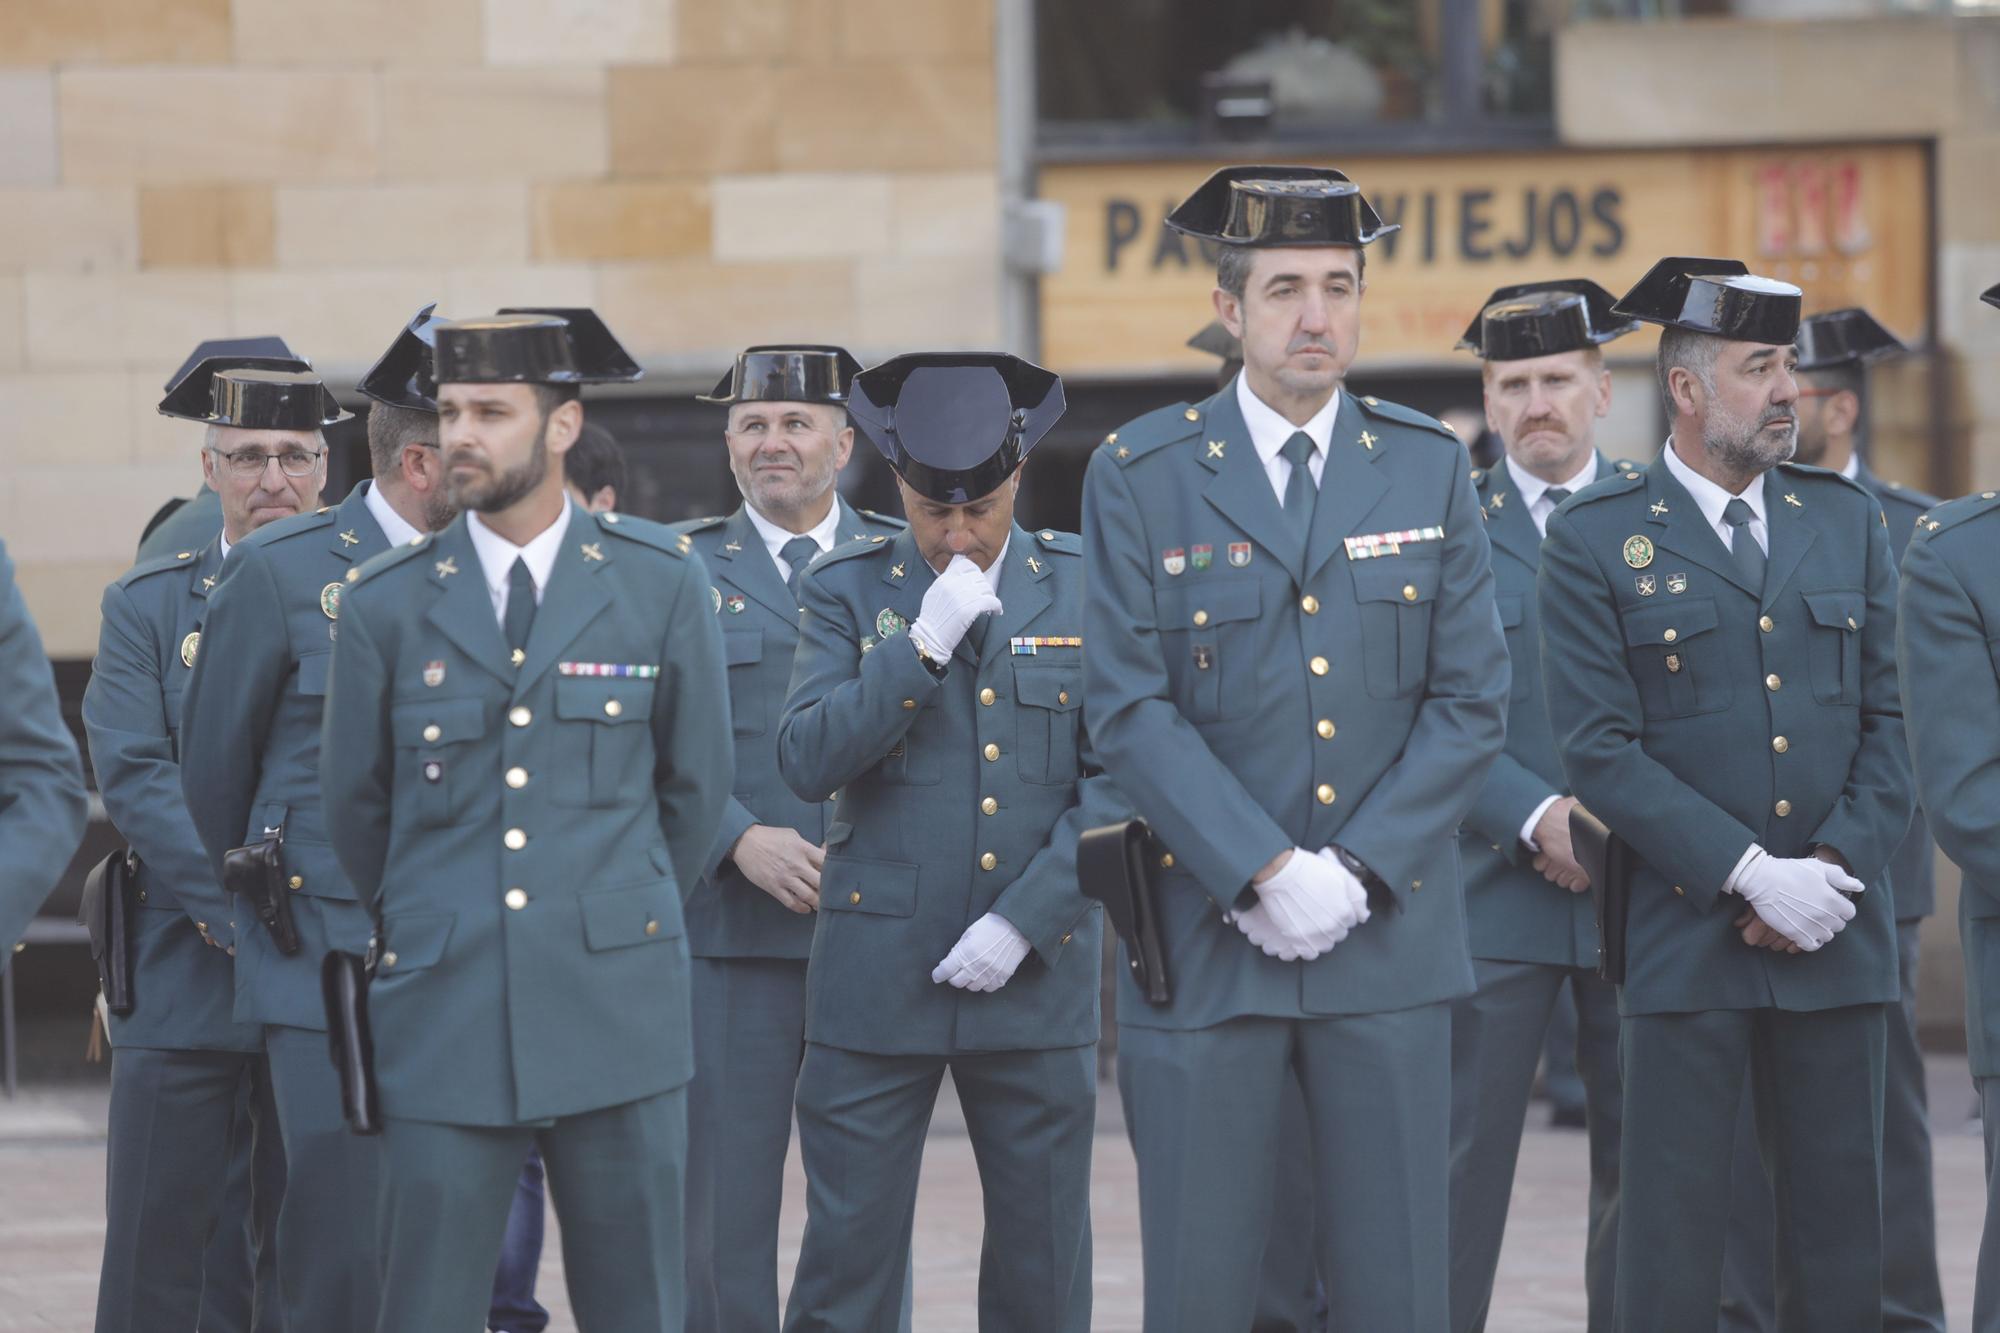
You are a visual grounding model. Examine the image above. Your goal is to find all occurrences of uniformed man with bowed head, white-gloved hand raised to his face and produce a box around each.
[778,352,1118,1333]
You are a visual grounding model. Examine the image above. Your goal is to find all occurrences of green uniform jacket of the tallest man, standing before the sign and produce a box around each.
[1084,384,1508,1029]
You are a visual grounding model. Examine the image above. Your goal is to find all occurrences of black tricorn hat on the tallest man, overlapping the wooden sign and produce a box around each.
[1166,166,1402,246]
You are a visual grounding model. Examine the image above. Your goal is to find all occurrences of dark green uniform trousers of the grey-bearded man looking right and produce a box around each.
[1616,1005,1886,1333]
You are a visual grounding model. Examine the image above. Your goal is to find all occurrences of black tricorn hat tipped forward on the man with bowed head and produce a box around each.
[848,352,1064,504]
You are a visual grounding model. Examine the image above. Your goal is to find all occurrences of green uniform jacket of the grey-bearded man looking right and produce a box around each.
[1540,460,1910,1013]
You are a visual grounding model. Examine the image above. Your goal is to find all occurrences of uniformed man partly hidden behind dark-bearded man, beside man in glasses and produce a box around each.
[180,306,452,1333]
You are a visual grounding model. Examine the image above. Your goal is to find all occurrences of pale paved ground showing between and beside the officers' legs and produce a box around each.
[0,1057,1984,1333]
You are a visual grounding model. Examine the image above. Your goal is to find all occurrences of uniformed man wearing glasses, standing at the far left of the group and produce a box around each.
[84,344,348,1333]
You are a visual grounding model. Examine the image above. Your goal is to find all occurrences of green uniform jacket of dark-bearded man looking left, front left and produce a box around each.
[320,508,732,1125]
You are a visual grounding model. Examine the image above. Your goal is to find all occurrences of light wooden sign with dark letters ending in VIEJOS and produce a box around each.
[1042,144,1930,374]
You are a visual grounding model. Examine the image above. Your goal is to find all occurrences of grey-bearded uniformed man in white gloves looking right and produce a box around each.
[1540,258,1910,1333]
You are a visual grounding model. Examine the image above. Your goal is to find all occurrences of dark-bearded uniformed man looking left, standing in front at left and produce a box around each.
[320,310,732,1333]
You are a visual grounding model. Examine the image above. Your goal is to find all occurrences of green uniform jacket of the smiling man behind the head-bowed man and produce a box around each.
[670,498,904,959]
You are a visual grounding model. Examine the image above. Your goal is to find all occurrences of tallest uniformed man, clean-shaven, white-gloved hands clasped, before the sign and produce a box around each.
[1084,166,1508,1333]
